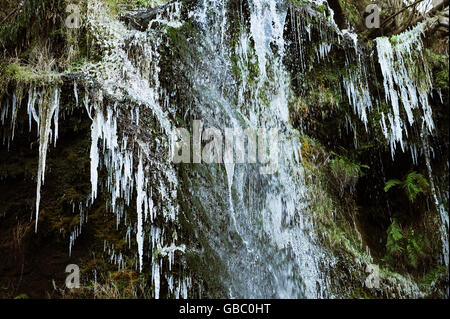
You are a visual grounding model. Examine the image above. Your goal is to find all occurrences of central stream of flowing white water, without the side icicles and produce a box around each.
[185,0,326,298]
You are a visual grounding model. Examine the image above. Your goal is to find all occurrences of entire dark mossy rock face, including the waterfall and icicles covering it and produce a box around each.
[0,0,449,298]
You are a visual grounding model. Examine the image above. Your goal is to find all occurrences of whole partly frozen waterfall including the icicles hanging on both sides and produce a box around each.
[0,0,448,298]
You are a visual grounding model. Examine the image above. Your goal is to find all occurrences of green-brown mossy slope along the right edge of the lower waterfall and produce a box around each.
[301,131,444,299]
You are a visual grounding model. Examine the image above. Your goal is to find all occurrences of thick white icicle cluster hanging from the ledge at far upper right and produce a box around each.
[377,24,434,154]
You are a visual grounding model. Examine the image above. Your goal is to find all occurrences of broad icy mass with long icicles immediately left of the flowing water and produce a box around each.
[78,1,190,298]
